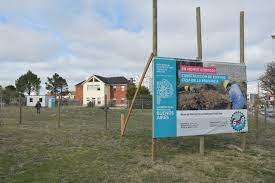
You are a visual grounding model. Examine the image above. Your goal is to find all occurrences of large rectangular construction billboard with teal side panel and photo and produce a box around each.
[153,57,248,138]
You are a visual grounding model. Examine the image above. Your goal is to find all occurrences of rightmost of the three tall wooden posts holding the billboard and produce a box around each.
[240,11,246,151]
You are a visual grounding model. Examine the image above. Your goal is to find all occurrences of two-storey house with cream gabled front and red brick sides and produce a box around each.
[75,75,130,107]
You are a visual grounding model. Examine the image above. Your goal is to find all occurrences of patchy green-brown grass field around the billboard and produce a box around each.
[0,107,275,183]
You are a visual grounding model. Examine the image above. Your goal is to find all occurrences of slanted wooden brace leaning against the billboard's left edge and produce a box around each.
[122,53,154,136]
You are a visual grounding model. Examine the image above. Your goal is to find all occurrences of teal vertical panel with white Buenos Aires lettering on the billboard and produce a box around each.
[153,57,177,138]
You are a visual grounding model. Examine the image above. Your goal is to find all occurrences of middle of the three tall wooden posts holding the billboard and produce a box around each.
[196,7,204,155]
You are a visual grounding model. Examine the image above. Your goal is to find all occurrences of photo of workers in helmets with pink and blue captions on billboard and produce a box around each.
[177,61,247,110]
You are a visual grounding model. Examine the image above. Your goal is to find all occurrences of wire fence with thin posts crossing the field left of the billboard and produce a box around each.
[0,96,152,129]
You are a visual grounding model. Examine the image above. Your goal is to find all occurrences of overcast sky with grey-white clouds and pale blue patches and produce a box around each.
[0,0,275,91]
